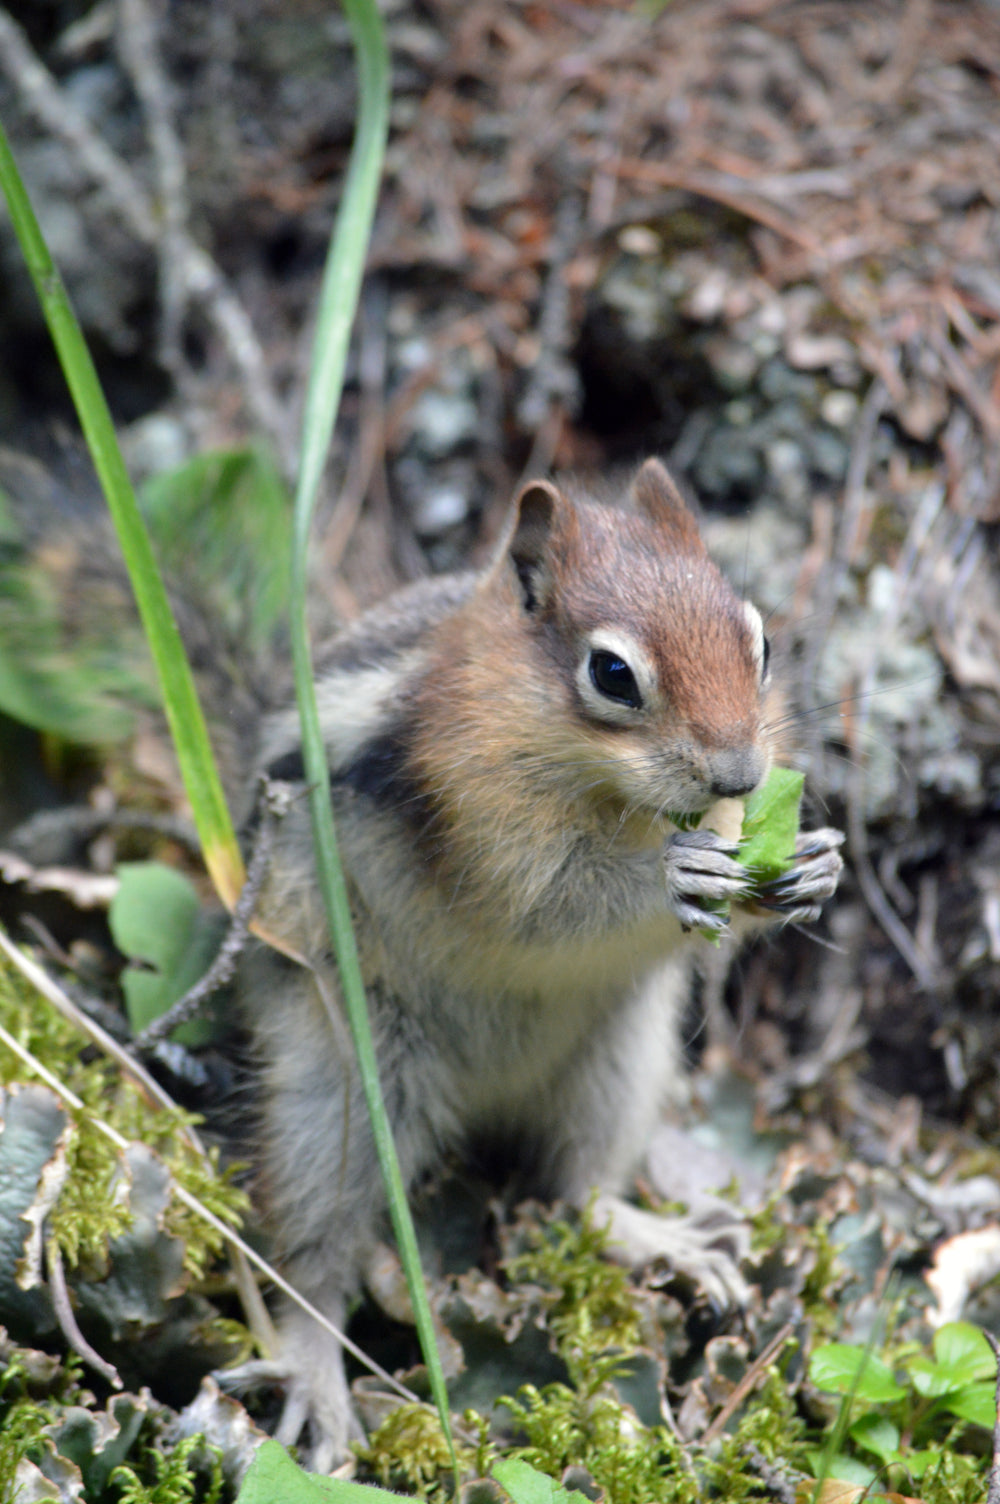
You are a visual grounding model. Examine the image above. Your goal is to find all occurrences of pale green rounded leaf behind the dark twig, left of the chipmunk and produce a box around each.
[108,862,215,1045]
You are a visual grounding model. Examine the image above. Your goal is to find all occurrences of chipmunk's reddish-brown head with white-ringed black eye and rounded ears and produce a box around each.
[501,460,770,814]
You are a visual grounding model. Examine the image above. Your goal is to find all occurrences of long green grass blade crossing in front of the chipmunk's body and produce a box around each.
[292,0,457,1478]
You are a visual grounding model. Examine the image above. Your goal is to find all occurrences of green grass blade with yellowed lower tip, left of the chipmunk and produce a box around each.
[0,126,244,907]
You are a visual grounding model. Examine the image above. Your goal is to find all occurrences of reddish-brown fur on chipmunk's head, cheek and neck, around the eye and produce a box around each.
[412,465,767,911]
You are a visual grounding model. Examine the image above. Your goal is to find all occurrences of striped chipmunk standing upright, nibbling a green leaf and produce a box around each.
[222,460,842,1469]
